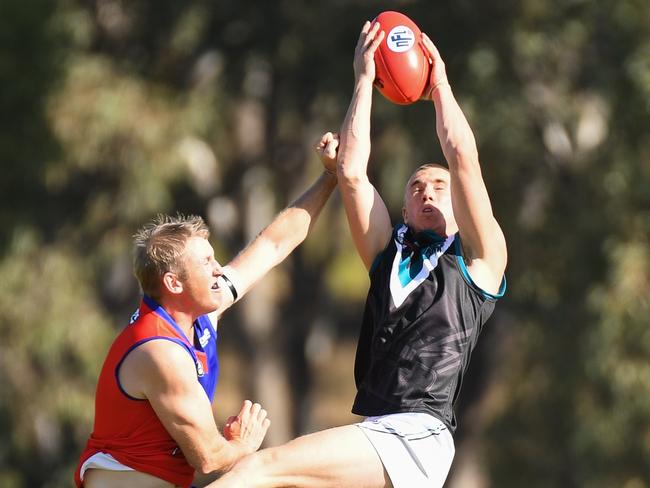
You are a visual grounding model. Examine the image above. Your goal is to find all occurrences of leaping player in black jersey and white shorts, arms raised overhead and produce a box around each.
[210,22,507,488]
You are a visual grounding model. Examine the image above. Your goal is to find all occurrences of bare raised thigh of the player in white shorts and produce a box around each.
[209,425,392,488]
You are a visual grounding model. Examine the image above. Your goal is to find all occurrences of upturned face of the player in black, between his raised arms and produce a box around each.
[403,166,458,236]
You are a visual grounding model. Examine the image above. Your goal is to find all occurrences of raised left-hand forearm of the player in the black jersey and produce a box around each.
[337,79,372,179]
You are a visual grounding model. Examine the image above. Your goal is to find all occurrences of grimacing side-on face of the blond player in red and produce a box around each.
[178,237,224,315]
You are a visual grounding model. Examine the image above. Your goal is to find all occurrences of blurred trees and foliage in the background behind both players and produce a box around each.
[0,0,650,488]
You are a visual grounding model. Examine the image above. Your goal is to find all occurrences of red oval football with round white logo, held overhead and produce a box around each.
[375,11,430,105]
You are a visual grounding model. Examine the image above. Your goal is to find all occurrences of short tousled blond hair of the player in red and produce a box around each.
[133,213,210,299]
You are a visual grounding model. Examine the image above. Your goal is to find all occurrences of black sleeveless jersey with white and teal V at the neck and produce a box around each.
[352,224,505,433]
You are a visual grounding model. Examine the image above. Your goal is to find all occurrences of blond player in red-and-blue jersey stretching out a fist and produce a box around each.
[75,134,337,488]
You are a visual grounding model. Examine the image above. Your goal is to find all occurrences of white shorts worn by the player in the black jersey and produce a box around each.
[357,413,456,488]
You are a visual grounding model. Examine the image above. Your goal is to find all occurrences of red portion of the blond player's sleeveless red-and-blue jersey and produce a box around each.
[75,297,218,487]
